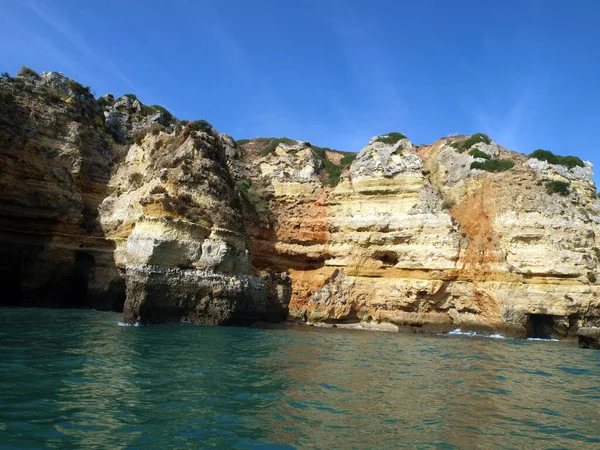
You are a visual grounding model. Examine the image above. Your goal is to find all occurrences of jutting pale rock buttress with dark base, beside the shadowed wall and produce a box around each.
[104,123,282,323]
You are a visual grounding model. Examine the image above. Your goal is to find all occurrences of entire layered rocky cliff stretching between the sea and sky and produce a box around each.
[0,69,600,336]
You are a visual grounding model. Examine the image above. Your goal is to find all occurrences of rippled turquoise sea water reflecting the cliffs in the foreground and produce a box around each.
[0,308,600,449]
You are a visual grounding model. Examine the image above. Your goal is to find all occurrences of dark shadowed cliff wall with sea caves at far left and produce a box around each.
[0,74,125,309]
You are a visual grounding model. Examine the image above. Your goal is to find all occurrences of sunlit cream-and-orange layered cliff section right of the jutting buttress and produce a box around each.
[238,137,600,336]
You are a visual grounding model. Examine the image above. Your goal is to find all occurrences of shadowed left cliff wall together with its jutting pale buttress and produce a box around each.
[0,74,289,324]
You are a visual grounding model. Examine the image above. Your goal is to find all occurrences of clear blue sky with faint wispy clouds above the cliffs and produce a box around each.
[0,0,600,169]
